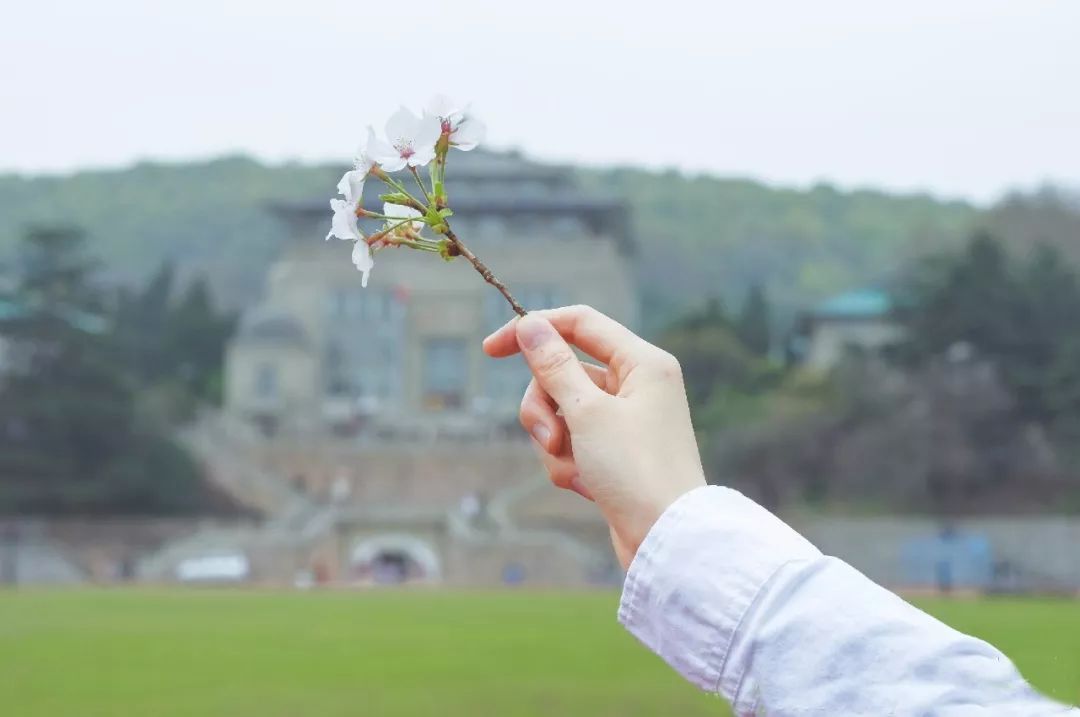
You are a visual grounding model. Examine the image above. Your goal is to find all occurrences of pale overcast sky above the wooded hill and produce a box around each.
[0,0,1080,201]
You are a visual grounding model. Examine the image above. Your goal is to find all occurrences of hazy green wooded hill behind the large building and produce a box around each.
[0,158,977,326]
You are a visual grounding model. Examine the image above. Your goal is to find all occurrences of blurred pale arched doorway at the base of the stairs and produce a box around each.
[349,533,442,585]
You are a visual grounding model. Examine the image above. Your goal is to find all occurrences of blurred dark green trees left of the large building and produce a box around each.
[0,227,232,515]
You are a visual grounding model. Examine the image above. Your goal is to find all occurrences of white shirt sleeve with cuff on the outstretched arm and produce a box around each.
[619,486,1080,717]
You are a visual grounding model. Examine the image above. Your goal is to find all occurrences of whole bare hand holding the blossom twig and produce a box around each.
[484,307,705,568]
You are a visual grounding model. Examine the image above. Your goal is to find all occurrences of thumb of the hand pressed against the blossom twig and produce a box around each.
[515,314,603,412]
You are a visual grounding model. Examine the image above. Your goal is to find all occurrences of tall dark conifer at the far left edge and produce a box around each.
[0,228,205,514]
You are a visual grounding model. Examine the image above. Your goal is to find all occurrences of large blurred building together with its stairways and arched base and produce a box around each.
[153,150,637,585]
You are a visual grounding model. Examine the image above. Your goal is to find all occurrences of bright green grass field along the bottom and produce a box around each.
[0,591,1080,717]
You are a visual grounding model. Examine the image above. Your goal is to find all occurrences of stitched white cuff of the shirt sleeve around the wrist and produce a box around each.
[619,486,821,701]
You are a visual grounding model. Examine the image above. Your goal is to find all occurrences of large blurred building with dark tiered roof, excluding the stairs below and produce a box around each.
[226,150,637,437]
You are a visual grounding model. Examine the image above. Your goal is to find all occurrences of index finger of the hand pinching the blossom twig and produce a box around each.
[484,306,649,364]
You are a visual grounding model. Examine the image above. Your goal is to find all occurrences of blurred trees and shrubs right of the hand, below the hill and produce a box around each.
[665,231,1080,515]
